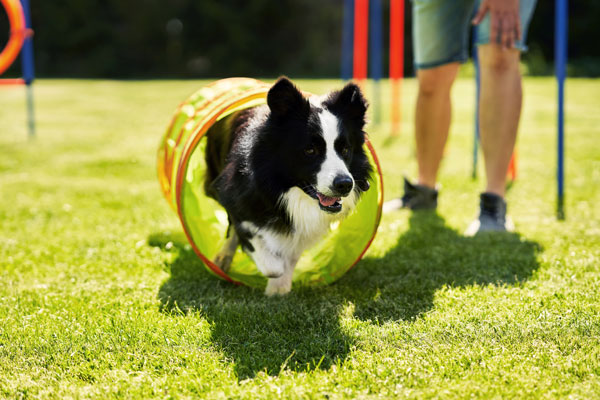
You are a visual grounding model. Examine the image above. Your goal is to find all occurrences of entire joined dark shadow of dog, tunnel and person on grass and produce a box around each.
[149,212,540,379]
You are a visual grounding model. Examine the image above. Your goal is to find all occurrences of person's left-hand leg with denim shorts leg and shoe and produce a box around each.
[384,0,475,212]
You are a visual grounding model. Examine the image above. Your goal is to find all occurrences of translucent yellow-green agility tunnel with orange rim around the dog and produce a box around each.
[157,78,383,288]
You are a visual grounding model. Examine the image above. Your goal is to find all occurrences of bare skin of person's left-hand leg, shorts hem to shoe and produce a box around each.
[415,63,459,188]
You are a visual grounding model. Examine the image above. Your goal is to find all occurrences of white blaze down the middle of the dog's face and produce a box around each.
[316,109,354,196]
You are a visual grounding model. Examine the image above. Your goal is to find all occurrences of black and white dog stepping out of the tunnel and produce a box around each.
[205,77,372,295]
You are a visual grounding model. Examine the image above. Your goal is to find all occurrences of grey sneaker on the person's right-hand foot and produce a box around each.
[465,193,515,236]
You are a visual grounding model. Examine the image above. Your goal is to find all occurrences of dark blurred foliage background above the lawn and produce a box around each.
[0,0,600,79]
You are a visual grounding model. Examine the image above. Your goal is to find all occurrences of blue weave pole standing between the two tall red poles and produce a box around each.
[369,0,383,124]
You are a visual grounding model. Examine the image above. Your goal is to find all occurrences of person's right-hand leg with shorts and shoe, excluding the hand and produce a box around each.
[465,0,536,235]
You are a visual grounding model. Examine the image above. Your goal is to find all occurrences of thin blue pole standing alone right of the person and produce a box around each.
[554,0,568,220]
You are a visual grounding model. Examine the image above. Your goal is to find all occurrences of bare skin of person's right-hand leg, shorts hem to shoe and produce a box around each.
[479,44,523,197]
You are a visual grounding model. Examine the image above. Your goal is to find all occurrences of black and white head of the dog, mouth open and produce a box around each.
[266,78,371,213]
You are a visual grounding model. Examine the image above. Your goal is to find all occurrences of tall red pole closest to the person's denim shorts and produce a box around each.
[390,0,404,136]
